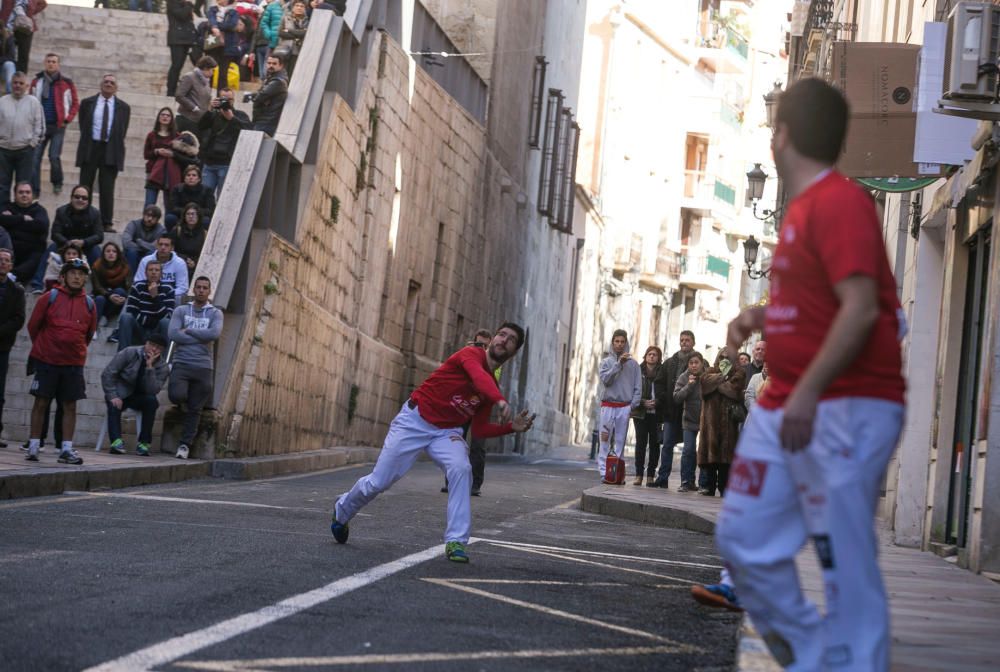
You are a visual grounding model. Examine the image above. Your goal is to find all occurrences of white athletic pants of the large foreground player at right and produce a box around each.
[715,397,903,672]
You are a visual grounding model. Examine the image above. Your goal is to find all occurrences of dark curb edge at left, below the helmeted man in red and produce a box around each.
[0,460,211,499]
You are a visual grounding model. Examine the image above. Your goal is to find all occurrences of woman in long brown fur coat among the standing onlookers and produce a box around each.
[698,350,747,497]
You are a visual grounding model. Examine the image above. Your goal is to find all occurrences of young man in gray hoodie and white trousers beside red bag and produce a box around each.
[597,329,642,481]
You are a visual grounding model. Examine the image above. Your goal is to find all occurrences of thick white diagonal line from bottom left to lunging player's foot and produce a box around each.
[85,544,441,672]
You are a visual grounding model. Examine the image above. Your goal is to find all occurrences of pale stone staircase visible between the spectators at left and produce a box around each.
[3,3,249,452]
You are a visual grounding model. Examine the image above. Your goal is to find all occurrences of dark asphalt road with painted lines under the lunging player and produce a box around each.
[0,454,739,671]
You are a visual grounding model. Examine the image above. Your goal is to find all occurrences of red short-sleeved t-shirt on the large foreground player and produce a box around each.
[759,172,906,409]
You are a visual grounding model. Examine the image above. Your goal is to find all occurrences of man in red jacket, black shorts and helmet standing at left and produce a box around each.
[25,259,97,464]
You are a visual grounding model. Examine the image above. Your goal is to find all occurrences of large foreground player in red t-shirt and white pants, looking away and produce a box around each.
[716,79,906,670]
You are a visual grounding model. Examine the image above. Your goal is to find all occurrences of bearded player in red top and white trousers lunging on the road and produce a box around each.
[330,322,535,562]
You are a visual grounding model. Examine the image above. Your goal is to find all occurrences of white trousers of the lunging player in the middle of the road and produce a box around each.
[334,404,472,544]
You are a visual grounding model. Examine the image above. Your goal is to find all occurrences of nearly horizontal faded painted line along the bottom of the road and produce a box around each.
[174,646,679,672]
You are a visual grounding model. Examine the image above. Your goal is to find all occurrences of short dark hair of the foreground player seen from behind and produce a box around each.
[774,77,848,165]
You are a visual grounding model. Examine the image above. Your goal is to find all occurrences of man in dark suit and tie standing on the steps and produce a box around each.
[76,74,132,231]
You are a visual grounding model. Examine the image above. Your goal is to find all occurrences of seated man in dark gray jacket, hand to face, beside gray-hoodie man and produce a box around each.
[101,334,170,457]
